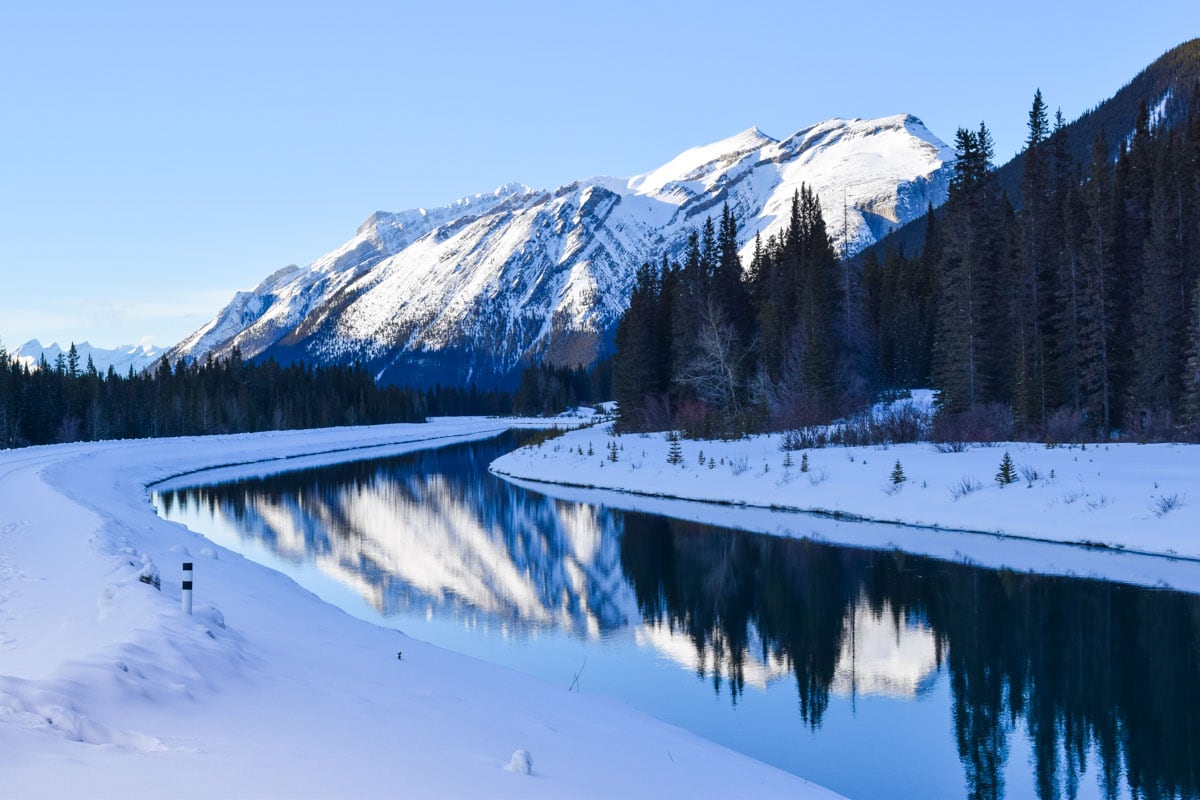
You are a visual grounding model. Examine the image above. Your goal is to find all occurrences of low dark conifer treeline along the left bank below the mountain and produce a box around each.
[0,344,511,447]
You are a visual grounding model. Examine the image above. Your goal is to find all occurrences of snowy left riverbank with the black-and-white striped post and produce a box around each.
[0,419,840,798]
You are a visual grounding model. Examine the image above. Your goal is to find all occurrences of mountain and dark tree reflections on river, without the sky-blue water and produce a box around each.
[157,437,1200,799]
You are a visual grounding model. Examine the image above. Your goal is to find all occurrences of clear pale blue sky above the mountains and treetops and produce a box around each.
[0,0,1200,347]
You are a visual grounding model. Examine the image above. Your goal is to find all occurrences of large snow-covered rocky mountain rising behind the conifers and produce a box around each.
[169,115,953,384]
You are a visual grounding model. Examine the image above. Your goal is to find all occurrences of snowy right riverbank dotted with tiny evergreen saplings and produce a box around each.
[492,425,1200,591]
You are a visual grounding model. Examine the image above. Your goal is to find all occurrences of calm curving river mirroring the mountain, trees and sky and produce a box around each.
[155,434,1200,800]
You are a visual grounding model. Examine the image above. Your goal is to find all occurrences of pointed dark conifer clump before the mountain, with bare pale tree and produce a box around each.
[612,194,849,435]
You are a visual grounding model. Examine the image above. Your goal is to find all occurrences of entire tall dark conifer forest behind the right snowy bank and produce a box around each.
[613,86,1200,440]
